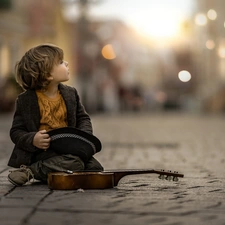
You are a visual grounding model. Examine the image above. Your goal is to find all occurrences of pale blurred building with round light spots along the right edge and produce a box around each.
[193,0,225,112]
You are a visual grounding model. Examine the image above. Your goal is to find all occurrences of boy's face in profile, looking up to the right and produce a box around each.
[51,61,70,83]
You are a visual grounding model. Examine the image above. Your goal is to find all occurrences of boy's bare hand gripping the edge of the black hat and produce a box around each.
[33,130,51,151]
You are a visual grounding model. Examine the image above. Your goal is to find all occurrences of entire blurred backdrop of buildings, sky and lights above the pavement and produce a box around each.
[0,0,225,113]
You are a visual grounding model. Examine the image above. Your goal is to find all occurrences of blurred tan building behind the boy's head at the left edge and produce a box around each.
[0,0,74,111]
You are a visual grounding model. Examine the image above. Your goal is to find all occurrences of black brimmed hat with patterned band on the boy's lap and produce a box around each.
[47,127,102,162]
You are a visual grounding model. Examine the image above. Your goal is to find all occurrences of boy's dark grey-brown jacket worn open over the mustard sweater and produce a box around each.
[8,84,92,168]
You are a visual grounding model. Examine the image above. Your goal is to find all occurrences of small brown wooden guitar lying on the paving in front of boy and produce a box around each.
[48,169,184,190]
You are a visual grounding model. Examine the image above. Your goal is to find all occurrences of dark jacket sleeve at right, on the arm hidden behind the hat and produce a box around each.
[75,89,93,134]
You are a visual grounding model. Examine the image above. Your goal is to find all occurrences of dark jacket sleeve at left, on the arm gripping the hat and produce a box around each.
[10,98,37,152]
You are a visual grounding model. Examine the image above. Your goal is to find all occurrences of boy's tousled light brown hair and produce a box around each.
[15,44,63,90]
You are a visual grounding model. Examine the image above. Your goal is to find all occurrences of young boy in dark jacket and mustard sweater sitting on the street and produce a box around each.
[8,44,103,186]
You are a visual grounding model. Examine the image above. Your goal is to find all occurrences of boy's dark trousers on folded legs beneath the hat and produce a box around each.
[29,154,103,182]
